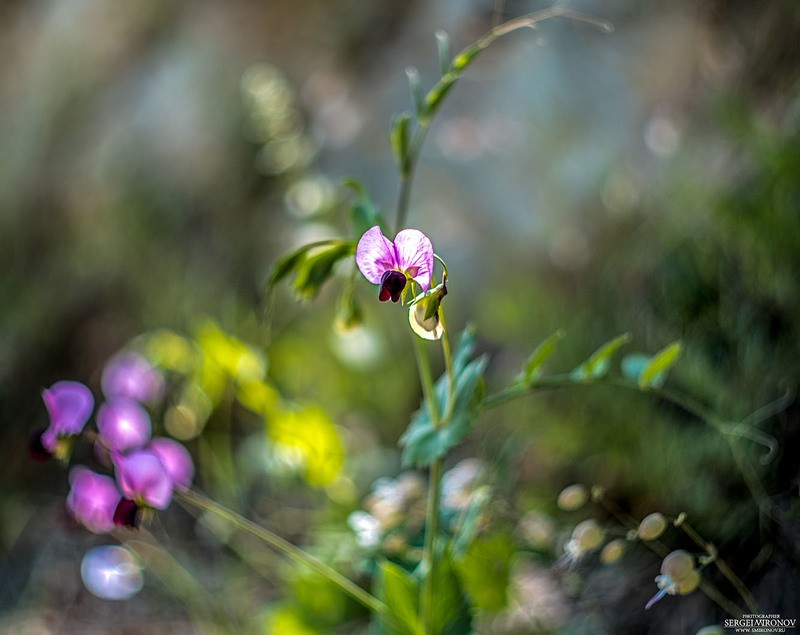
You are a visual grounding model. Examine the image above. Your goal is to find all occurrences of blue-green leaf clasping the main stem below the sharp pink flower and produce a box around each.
[400,330,489,467]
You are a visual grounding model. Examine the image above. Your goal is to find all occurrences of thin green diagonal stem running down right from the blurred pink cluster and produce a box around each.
[176,490,387,614]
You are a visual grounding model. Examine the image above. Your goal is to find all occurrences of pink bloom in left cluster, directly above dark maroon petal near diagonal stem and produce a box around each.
[114,450,172,509]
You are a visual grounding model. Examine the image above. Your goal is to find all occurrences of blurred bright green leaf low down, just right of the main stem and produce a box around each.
[457,532,514,613]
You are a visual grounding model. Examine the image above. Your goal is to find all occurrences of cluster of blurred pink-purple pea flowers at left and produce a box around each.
[31,353,194,533]
